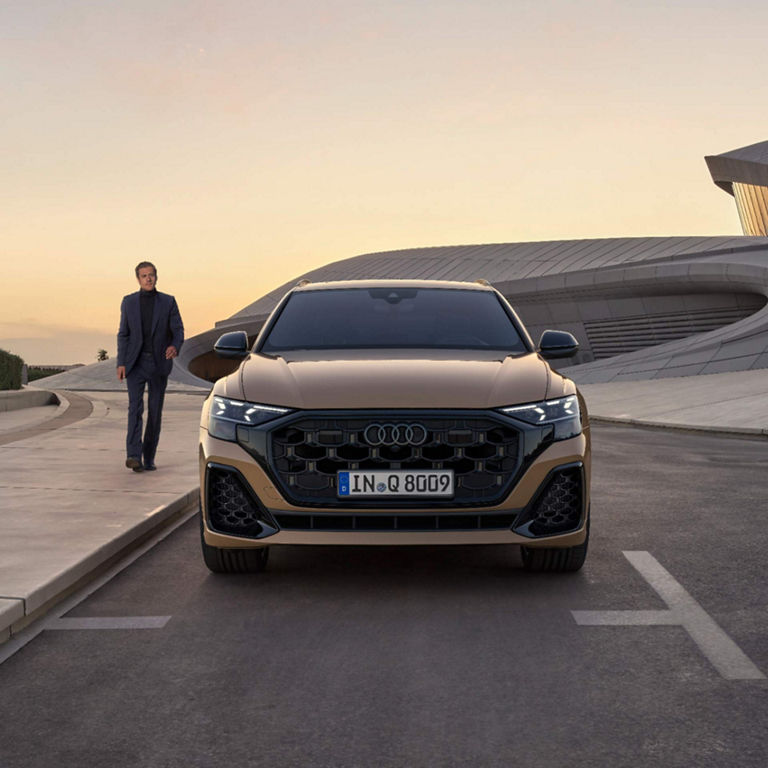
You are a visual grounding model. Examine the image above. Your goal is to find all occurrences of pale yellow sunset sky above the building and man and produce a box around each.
[0,0,768,364]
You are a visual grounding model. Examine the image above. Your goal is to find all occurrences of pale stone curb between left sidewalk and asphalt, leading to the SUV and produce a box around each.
[0,486,200,644]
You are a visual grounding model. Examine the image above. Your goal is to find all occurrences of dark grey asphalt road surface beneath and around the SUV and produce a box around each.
[0,426,768,768]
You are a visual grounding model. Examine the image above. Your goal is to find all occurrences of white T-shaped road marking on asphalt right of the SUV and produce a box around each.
[571,552,765,680]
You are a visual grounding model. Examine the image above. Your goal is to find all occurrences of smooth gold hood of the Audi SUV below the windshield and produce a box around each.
[230,350,568,409]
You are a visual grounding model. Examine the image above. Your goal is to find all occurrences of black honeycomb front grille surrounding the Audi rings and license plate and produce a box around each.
[271,412,520,507]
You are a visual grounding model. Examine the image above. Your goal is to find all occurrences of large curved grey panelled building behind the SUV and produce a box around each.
[181,237,768,382]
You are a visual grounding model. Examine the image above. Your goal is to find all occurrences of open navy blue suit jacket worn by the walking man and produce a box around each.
[117,291,184,376]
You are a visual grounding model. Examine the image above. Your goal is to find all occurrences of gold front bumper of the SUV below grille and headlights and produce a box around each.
[200,428,590,548]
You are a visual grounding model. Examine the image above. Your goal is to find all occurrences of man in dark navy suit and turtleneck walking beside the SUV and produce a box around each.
[117,261,184,472]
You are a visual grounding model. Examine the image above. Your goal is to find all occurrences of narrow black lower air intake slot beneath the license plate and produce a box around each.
[275,512,516,531]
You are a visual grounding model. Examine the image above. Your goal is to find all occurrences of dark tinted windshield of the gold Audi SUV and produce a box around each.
[259,288,528,354]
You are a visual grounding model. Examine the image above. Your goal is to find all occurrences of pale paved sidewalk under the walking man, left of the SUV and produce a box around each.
[0,392,203,642]
